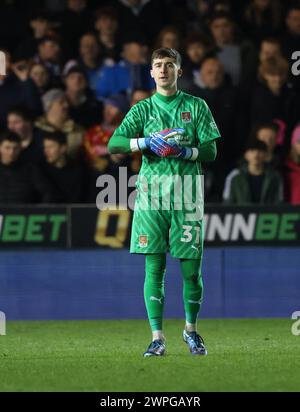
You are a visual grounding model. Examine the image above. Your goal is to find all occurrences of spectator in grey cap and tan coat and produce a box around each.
[35,89,84,158]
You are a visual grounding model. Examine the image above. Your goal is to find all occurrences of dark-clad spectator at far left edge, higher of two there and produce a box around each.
[0,53,42,129]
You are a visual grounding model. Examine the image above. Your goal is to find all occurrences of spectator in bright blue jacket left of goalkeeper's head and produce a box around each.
[96,40,155,99]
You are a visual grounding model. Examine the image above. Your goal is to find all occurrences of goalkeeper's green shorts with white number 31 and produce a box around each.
[130,200,203,259]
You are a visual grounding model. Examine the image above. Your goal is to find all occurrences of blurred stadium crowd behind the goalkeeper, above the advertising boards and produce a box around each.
[0,0,300,205]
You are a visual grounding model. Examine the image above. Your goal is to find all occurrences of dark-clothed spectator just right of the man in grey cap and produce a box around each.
[64,66,102,129]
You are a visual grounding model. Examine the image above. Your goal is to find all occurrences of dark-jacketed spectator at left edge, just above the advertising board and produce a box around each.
[0,132,53,205]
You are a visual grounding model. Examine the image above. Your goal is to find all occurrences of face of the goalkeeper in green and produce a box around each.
[150,57,182,90]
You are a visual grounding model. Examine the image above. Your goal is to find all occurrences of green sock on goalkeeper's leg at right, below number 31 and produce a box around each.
[180,259,203,323]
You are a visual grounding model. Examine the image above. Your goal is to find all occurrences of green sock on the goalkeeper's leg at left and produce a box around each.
[144,254,166,331]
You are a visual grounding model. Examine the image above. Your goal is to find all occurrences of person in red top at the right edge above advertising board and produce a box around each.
[284,125,300,205]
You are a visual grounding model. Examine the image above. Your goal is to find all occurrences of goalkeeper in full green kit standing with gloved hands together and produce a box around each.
[108,48,220,357]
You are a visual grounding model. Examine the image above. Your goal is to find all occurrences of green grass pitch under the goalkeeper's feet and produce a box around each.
[0,319,300,392]
